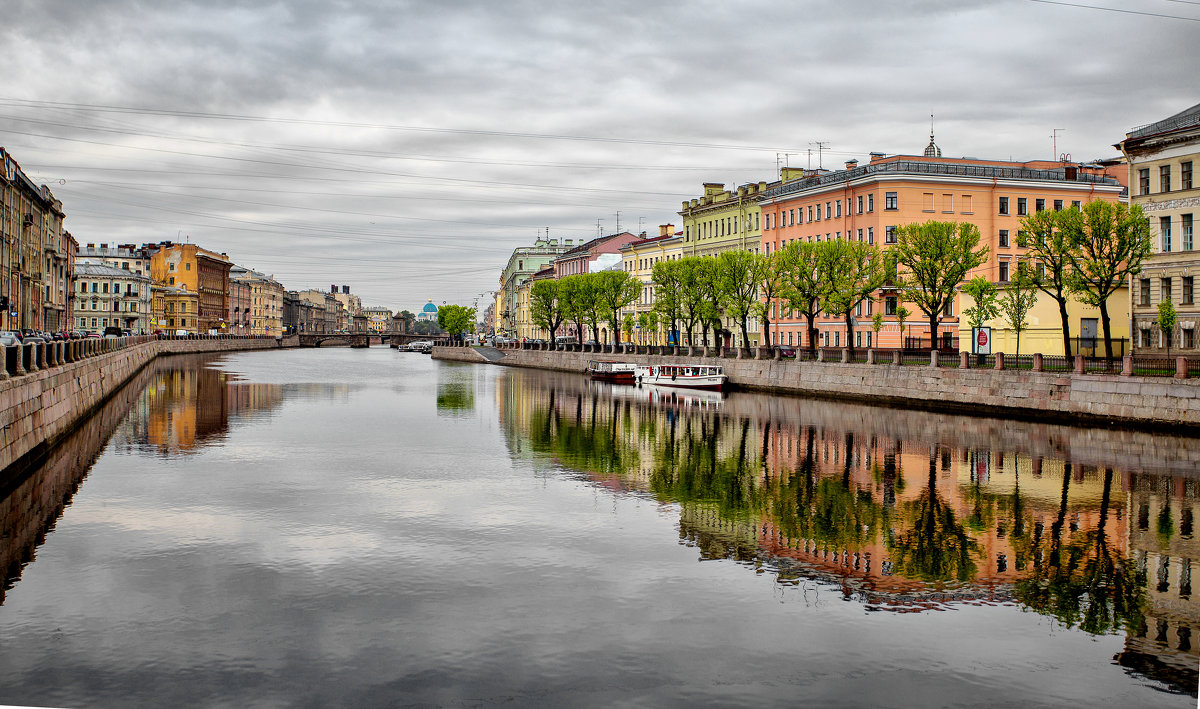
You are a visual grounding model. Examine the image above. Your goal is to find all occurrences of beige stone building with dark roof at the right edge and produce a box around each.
[1116,103,1200,354]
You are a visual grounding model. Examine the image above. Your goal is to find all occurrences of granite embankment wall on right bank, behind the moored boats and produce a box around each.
[433,347,1200,432]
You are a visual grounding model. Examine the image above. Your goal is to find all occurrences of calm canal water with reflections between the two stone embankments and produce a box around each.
[0,348,1200,708]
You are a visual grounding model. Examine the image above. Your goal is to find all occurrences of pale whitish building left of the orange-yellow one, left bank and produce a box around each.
[72,259,154,335]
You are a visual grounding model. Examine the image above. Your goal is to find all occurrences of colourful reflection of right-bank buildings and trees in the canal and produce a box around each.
[497,372,1200,692]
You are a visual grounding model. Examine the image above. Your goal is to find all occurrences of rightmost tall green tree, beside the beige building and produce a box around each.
[1058,199,1150,362]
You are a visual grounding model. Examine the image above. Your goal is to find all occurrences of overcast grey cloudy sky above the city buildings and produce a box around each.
[0,0,1200,312]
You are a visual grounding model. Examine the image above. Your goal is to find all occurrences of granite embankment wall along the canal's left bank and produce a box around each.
[0,337,280,470]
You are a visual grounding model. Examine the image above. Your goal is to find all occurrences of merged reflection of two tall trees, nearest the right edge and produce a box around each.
[1014,463,1145,635]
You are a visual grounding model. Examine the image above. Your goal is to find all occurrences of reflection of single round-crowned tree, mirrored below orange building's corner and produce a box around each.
[888,447,980,582]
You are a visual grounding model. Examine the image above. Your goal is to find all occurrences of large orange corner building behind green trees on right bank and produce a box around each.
[761,142,1124,354]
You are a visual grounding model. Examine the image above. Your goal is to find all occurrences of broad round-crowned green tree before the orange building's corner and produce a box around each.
[888,221,988,349]
